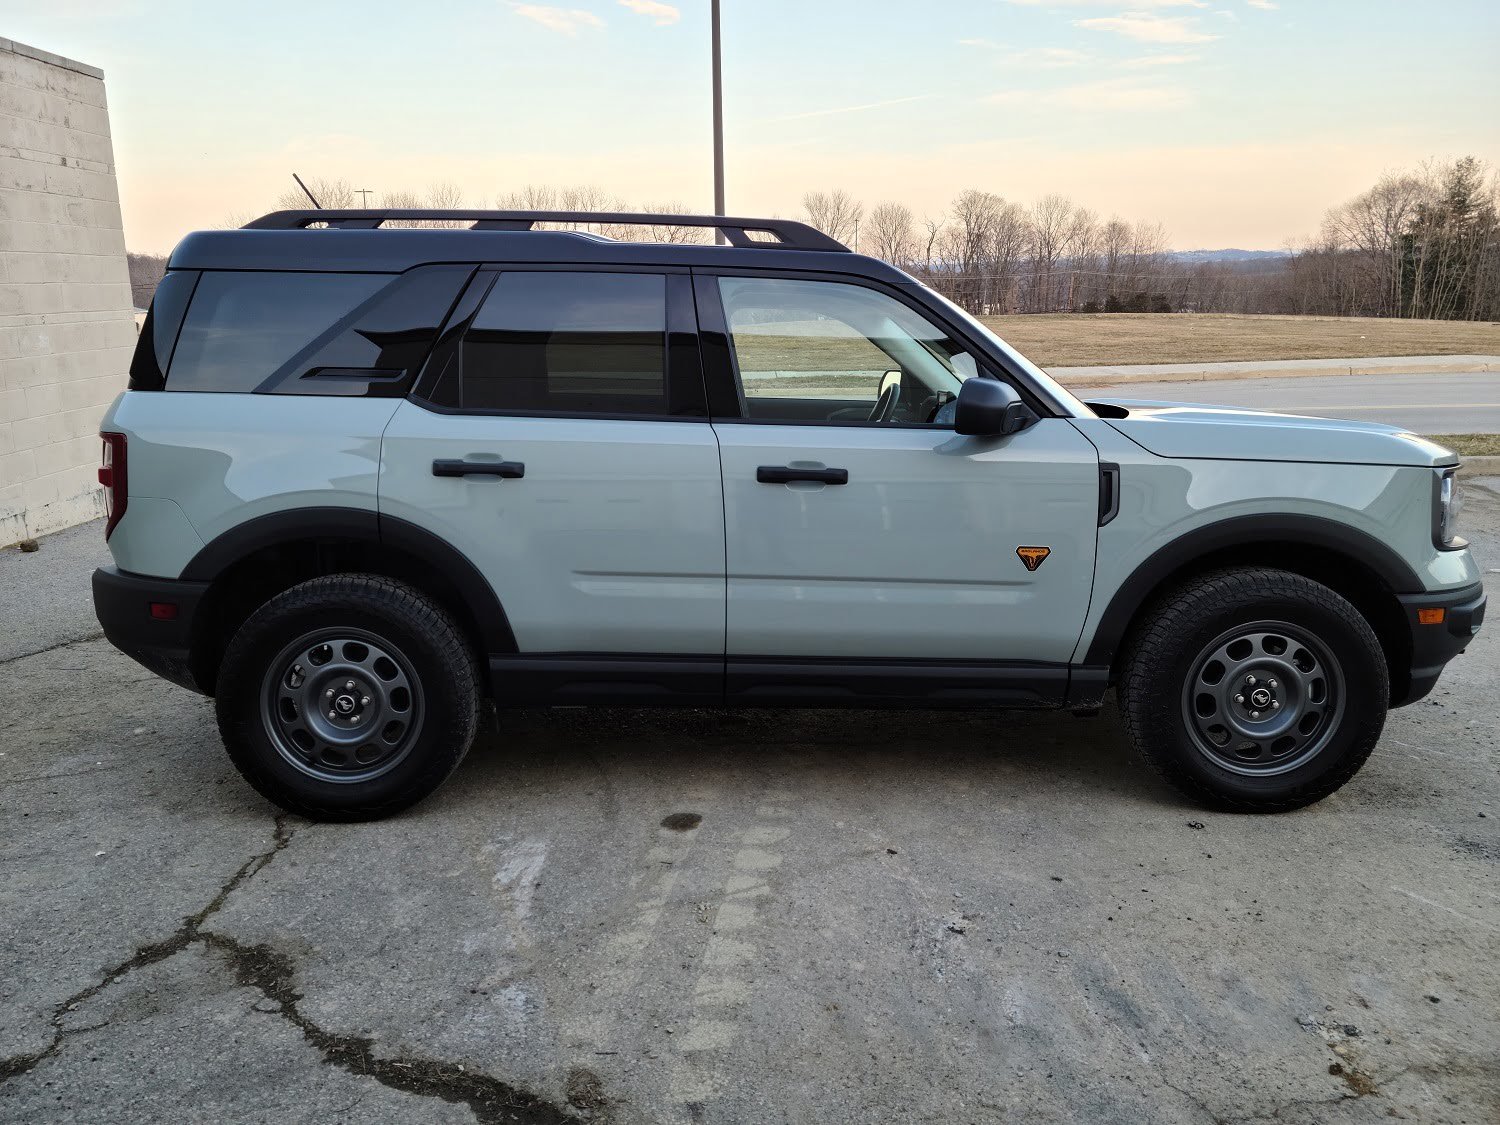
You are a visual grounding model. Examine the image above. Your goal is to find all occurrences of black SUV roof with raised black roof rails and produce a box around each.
[168,209,912,284]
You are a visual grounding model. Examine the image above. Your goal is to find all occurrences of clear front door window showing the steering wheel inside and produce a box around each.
[719,278,978,426]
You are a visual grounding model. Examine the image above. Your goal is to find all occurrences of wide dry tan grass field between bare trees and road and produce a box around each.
[984,312,1500,368]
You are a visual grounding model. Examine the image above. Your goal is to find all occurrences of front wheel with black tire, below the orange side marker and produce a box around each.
[1119,567,1391,812]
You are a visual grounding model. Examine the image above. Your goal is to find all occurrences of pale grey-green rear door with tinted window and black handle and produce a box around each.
[380,266,725,692]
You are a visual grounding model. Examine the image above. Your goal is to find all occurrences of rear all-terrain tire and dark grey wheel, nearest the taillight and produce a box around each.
[216,575,480,821]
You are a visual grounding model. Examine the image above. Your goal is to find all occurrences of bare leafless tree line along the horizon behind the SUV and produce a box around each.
[131,158,1500,320]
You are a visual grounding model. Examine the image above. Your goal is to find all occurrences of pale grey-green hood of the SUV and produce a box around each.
[1089,398,1458,468]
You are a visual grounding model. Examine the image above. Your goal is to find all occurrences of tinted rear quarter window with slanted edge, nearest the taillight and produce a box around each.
[167,272,390,392]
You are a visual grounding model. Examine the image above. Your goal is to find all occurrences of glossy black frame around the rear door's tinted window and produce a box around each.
[407,263,710,425]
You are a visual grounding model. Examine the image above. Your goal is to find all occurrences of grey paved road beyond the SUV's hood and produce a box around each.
[1073,371,1500,434]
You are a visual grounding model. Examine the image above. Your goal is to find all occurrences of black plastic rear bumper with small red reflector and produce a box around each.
[93,567,210,695]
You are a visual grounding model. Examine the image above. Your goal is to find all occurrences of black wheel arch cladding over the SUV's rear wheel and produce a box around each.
[182,507,516,692]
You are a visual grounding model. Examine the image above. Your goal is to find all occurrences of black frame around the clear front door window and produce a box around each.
[693,266,1064,431]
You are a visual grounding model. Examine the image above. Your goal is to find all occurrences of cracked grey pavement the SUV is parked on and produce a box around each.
[0,492,1500,1125]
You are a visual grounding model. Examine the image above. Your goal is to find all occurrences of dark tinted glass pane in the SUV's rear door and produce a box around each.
[459,272,669,414]
